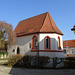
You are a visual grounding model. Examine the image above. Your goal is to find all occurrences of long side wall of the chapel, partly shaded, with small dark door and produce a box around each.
[8,34,38,55]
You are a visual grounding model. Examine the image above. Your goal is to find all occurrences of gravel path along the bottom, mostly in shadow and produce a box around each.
[0,65,75,75]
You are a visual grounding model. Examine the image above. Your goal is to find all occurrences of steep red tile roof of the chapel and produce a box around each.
[14,12,63,36]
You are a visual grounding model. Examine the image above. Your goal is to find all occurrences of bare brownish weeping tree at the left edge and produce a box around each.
[0,21,16,47]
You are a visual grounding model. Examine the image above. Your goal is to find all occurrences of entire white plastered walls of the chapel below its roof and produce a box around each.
[8,33,63,57]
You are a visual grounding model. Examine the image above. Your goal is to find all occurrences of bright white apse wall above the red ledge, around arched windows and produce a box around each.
[39,33,63,50]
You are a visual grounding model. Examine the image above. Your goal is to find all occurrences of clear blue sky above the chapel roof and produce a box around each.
[0,0,75,40]
